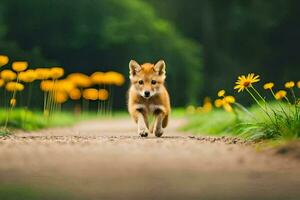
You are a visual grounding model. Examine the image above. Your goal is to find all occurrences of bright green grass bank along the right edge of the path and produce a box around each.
[182,103,300,140]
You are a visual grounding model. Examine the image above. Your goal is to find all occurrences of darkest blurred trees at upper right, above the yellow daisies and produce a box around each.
[147,0,300,103]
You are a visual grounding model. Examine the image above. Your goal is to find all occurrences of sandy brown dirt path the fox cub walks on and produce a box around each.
[0,119,300,200]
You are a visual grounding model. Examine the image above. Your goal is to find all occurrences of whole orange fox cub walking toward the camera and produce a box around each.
[128,60,171,137]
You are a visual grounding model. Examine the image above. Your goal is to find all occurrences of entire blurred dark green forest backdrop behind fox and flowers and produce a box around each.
[0,0,300,109]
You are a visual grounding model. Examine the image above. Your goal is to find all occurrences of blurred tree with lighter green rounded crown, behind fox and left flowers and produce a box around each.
[0,0,202,105]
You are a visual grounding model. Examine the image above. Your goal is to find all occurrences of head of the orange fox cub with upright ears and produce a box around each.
[129,60,166,99]
